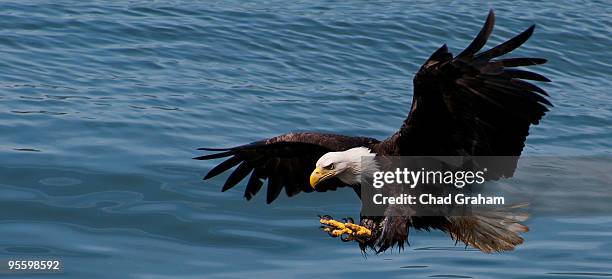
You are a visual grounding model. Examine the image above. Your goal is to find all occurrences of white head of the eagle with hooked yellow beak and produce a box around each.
[310,147,378,188]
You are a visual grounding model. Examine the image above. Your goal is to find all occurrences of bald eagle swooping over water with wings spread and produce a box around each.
[194,10,552,255]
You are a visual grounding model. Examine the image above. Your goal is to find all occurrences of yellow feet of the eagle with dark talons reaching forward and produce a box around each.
[319,215,372,242]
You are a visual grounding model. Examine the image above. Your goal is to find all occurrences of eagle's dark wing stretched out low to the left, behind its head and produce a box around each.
[194,133,378,203]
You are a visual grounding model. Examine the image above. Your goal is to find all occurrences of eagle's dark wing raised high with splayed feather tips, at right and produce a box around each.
[395,10,552,170]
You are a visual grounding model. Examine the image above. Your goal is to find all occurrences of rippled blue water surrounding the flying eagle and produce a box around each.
[0,0,612,278]
